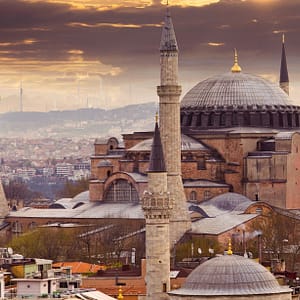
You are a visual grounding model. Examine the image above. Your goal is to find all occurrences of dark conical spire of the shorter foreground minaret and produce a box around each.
[149,115,166,172]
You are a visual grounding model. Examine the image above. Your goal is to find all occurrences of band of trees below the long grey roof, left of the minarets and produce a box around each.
[7,219,145,265]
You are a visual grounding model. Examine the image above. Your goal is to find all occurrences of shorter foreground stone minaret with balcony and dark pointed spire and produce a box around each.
[142,116,172,300]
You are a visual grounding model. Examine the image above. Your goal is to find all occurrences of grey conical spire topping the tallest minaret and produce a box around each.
[159,1,178,51]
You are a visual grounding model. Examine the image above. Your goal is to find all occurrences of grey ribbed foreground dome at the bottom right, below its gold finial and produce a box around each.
[170,255,291,296]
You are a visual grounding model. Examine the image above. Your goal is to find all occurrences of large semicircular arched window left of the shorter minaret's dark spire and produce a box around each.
[103,179,139,203]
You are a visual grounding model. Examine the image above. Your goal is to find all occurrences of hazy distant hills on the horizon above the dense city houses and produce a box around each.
[0,102,157,137]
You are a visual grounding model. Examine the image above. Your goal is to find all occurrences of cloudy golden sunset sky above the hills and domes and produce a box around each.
[0,0,300,112]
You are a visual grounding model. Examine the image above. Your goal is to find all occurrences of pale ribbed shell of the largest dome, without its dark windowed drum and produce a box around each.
[181,72,291,108]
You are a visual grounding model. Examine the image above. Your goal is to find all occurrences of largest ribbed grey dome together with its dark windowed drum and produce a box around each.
[181,72,300,129]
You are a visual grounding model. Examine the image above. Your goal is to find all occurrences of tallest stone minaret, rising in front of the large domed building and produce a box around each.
[157,4,191,245]
